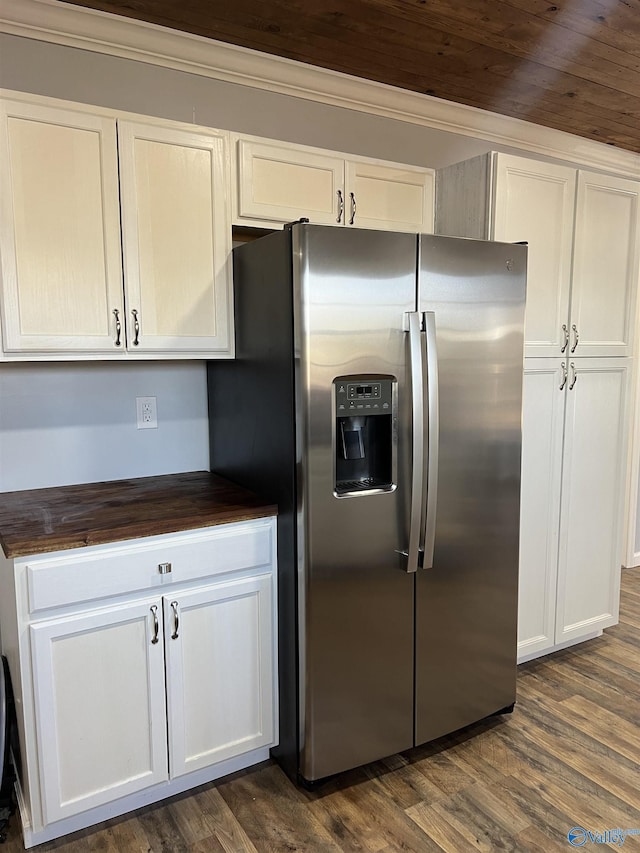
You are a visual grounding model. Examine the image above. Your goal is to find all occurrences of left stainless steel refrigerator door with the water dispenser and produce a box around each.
[293,225,417,780]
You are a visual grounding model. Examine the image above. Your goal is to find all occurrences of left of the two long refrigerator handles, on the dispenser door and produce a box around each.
[402,311,424,573]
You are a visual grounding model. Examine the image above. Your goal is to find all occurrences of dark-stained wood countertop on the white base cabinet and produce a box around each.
[0,471,276,558]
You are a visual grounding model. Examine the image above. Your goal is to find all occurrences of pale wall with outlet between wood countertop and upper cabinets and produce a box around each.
[0,361,209,491]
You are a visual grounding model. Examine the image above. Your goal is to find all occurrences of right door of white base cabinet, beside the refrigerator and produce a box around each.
[164,575,274,778]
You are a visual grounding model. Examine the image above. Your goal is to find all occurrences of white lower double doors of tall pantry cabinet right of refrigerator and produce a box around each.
[518,357,628,660]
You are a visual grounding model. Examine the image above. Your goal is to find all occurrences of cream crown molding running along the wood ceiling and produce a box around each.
[0,0,640,179]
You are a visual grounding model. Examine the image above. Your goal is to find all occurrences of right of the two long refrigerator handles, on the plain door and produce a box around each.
[421,311,440,569]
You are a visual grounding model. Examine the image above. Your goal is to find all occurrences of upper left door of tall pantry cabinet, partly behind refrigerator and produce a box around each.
[492,154,576,356]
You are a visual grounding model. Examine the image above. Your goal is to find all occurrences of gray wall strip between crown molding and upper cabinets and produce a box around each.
[0,34,490,168]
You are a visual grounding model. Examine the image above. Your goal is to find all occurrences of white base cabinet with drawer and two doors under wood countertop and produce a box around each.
[0,518,277,847]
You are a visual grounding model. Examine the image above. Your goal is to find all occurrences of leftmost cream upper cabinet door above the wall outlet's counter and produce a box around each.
[0,101,123,353]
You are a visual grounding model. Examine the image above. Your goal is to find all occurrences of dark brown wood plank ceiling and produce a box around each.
[65,0,640,153]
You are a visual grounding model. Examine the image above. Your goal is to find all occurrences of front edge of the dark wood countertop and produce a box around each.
[0,504,278,560]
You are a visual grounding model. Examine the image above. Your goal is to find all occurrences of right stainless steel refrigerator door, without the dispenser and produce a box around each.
[415,235,527,744]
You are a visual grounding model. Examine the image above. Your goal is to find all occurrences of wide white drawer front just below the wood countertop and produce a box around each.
[24,519,275,613]
